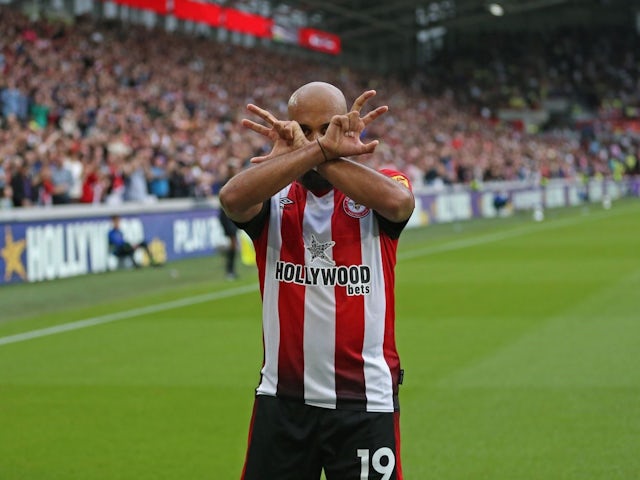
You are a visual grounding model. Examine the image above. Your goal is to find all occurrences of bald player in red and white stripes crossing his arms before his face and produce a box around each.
[220,82,414,480]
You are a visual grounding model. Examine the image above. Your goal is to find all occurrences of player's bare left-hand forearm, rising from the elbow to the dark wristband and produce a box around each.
[220,142,324,222]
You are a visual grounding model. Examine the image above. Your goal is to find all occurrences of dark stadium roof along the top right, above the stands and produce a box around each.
[283,0,637,62]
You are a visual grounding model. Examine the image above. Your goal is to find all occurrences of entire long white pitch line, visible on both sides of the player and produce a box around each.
[0,202,622,346]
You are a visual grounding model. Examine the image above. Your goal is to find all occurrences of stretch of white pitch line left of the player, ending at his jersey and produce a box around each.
[0,284,258,346]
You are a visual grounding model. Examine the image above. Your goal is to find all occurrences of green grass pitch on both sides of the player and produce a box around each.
[0,199,640,480]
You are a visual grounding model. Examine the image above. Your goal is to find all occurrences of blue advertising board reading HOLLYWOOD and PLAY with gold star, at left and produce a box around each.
[0,209,225,285]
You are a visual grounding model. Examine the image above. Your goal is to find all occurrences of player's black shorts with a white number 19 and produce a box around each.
[241,395,402,480]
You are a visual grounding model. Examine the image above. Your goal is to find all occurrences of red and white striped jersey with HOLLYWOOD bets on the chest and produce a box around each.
[241,170,409,412]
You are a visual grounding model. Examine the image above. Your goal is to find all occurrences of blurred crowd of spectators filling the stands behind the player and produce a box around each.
[0,7,640,208]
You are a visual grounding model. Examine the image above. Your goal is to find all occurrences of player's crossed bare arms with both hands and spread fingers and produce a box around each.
[220,90,415,222]
